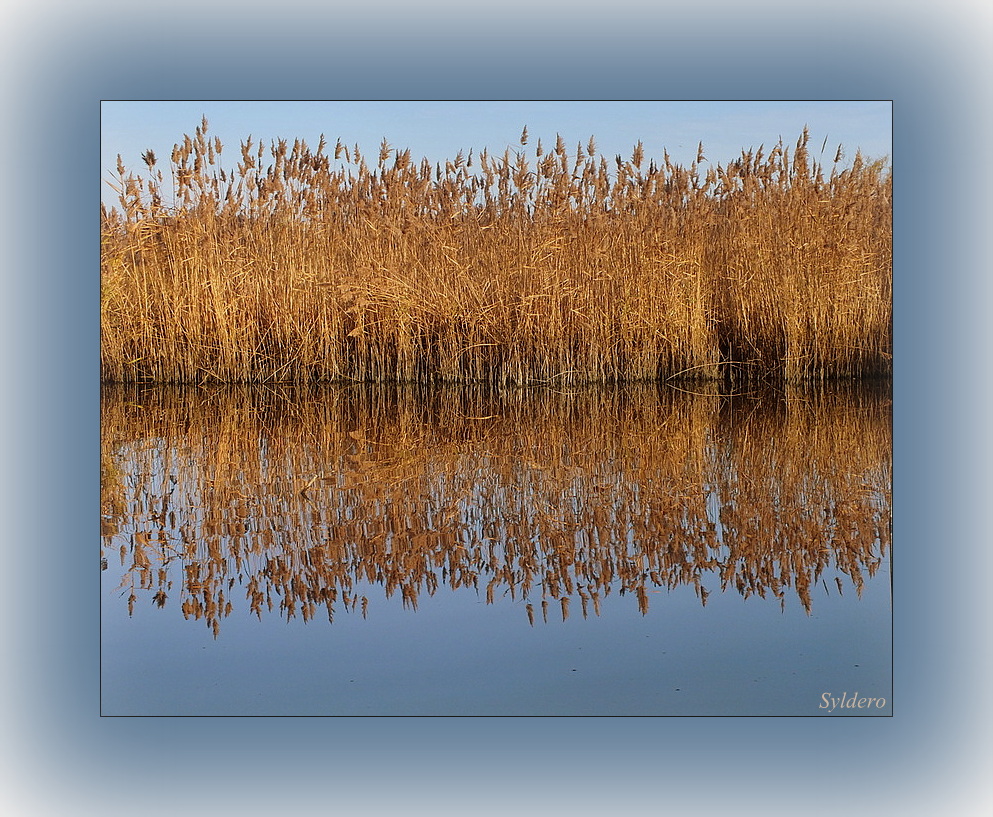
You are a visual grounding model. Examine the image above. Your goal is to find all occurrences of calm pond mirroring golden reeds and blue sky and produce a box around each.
[101,383,892,717]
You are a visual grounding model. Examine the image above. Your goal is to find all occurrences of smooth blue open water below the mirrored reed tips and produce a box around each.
[102,560,891,715]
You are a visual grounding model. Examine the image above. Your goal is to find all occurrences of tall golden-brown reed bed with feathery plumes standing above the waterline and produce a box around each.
[101,120,892,385]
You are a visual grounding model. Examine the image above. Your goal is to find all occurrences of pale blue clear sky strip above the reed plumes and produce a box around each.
[101,100,893,203]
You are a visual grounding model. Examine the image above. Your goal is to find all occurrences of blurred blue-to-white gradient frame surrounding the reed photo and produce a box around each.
[0,2,993,815]
